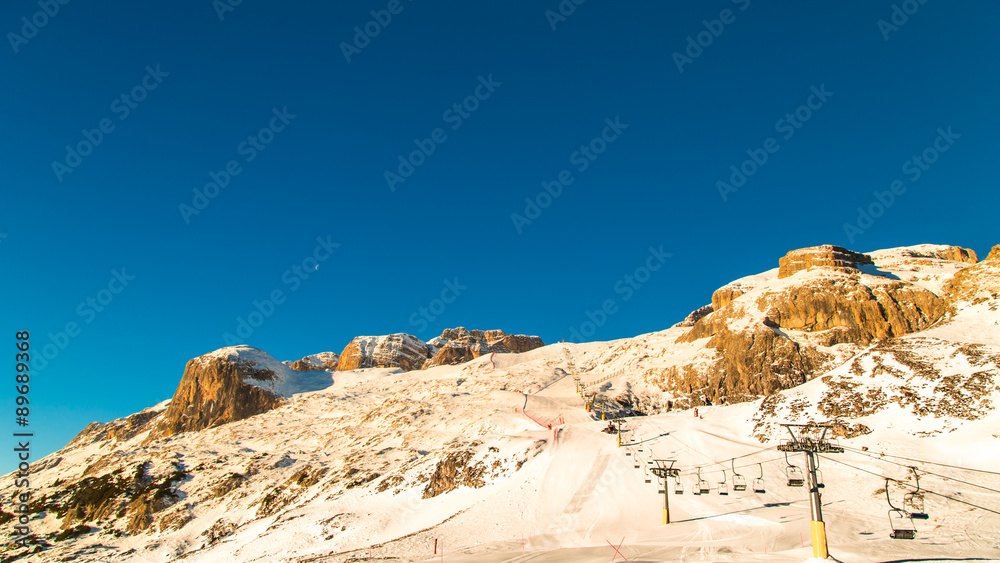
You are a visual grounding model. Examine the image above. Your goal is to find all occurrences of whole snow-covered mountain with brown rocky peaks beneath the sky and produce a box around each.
[0,245,1000,562]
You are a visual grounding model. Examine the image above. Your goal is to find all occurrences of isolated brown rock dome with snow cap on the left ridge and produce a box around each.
[150,346,333,438]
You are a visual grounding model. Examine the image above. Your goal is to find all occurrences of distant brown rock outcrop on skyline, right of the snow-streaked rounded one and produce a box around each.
[423,327,545,369]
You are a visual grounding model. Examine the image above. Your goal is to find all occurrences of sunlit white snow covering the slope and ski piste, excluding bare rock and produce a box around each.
[0,247,1000,563]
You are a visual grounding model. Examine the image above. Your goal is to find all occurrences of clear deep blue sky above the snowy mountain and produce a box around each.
[0,0,1000,471]
